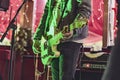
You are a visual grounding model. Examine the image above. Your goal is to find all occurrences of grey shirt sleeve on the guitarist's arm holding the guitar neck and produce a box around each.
[67,0,91,41]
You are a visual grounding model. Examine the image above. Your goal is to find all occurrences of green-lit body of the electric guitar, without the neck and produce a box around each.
[40,27,63,65]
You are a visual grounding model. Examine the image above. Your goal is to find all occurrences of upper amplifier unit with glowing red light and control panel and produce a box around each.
[80,52,109,72]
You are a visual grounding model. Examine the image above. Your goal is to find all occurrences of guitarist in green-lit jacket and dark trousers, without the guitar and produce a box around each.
[32,0,91,80]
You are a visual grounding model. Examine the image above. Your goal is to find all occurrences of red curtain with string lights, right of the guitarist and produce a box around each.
[85,0,116,43]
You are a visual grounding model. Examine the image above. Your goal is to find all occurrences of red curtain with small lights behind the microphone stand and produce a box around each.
[0,0,23,39]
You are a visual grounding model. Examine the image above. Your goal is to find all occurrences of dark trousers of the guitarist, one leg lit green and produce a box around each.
[51,42,82,80]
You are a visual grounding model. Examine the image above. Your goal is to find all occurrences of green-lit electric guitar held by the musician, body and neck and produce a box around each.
[40,19,87,65]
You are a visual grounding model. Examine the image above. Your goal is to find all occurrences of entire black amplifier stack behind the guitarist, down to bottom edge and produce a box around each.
[75,52,109,80]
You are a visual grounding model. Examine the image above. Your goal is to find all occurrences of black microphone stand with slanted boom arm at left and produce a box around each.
[0,0,27,80]
